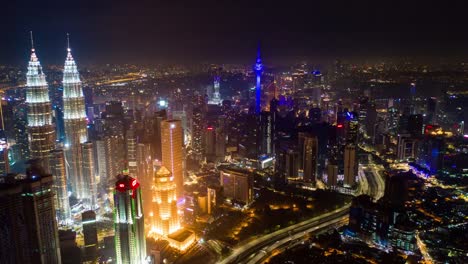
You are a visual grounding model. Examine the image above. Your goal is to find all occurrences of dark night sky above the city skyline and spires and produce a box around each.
[0,0,468,65]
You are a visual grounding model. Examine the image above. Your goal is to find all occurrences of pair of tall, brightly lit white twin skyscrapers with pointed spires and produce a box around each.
[26,35,96,217]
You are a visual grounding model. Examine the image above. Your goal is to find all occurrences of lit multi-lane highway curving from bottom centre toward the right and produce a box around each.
[220,155,385,264]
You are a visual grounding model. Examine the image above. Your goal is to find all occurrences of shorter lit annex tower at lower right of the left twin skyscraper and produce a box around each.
[50,149,71,223]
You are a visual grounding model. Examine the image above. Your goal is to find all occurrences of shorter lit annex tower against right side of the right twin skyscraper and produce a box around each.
[80,142,97,209]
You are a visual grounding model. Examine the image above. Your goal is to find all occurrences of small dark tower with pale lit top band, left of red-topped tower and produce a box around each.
[81,210,98,261]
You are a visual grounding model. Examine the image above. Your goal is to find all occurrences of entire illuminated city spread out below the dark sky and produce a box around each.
[0,1,468,264]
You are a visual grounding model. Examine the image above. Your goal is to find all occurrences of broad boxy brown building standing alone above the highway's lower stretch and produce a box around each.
[220,168,253,204]
